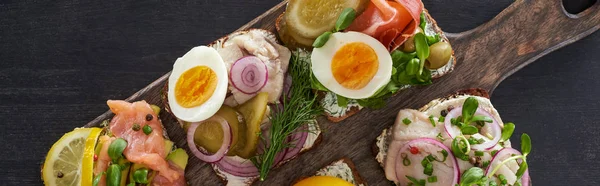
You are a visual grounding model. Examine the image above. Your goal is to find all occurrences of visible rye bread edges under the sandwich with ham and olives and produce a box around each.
[275,8,456,123]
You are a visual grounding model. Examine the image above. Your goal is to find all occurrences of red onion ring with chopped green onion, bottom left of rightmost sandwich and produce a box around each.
[395,138,460,185]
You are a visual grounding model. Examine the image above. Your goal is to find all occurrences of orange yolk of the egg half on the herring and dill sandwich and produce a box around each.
[175,66,217,108]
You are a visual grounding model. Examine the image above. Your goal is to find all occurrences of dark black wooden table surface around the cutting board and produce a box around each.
[0,0,600,185]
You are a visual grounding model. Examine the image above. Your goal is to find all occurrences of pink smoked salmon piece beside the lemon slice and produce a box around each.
[106,100,183,182]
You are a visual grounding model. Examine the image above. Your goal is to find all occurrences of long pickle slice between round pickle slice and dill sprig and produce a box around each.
[234,92,269,159]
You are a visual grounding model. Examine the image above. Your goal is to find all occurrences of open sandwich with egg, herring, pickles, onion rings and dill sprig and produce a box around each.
[164,29,321,185]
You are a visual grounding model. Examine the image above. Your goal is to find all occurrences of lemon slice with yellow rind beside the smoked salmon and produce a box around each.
[42,128,102,186]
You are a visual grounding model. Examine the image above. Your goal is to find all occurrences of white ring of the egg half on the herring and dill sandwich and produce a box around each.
[167,46,229,122]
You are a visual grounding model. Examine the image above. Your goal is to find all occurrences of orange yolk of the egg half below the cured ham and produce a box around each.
[331,42,379,90]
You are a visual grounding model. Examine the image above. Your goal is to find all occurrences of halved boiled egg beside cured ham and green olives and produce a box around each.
[311,32,392,99]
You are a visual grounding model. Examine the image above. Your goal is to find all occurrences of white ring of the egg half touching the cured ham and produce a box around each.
[311,32,392,99]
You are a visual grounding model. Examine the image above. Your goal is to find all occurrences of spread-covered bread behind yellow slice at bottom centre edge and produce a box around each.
[294,157,367,186]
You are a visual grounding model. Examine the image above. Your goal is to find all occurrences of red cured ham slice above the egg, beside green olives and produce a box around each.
[347,0,423,51]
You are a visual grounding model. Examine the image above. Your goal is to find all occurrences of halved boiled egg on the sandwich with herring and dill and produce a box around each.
[168,46,228,122]
